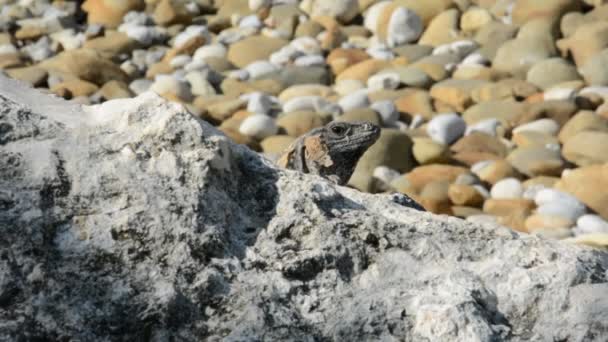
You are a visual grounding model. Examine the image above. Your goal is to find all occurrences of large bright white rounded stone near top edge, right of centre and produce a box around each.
[386,7,424,47]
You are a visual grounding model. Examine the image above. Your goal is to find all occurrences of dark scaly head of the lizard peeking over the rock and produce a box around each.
[323,121,380,154]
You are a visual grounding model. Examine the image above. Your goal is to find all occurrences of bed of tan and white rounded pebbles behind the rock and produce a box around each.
[0,0,608,247]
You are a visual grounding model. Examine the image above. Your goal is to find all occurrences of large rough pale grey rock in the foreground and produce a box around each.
[0,77,608,341]
